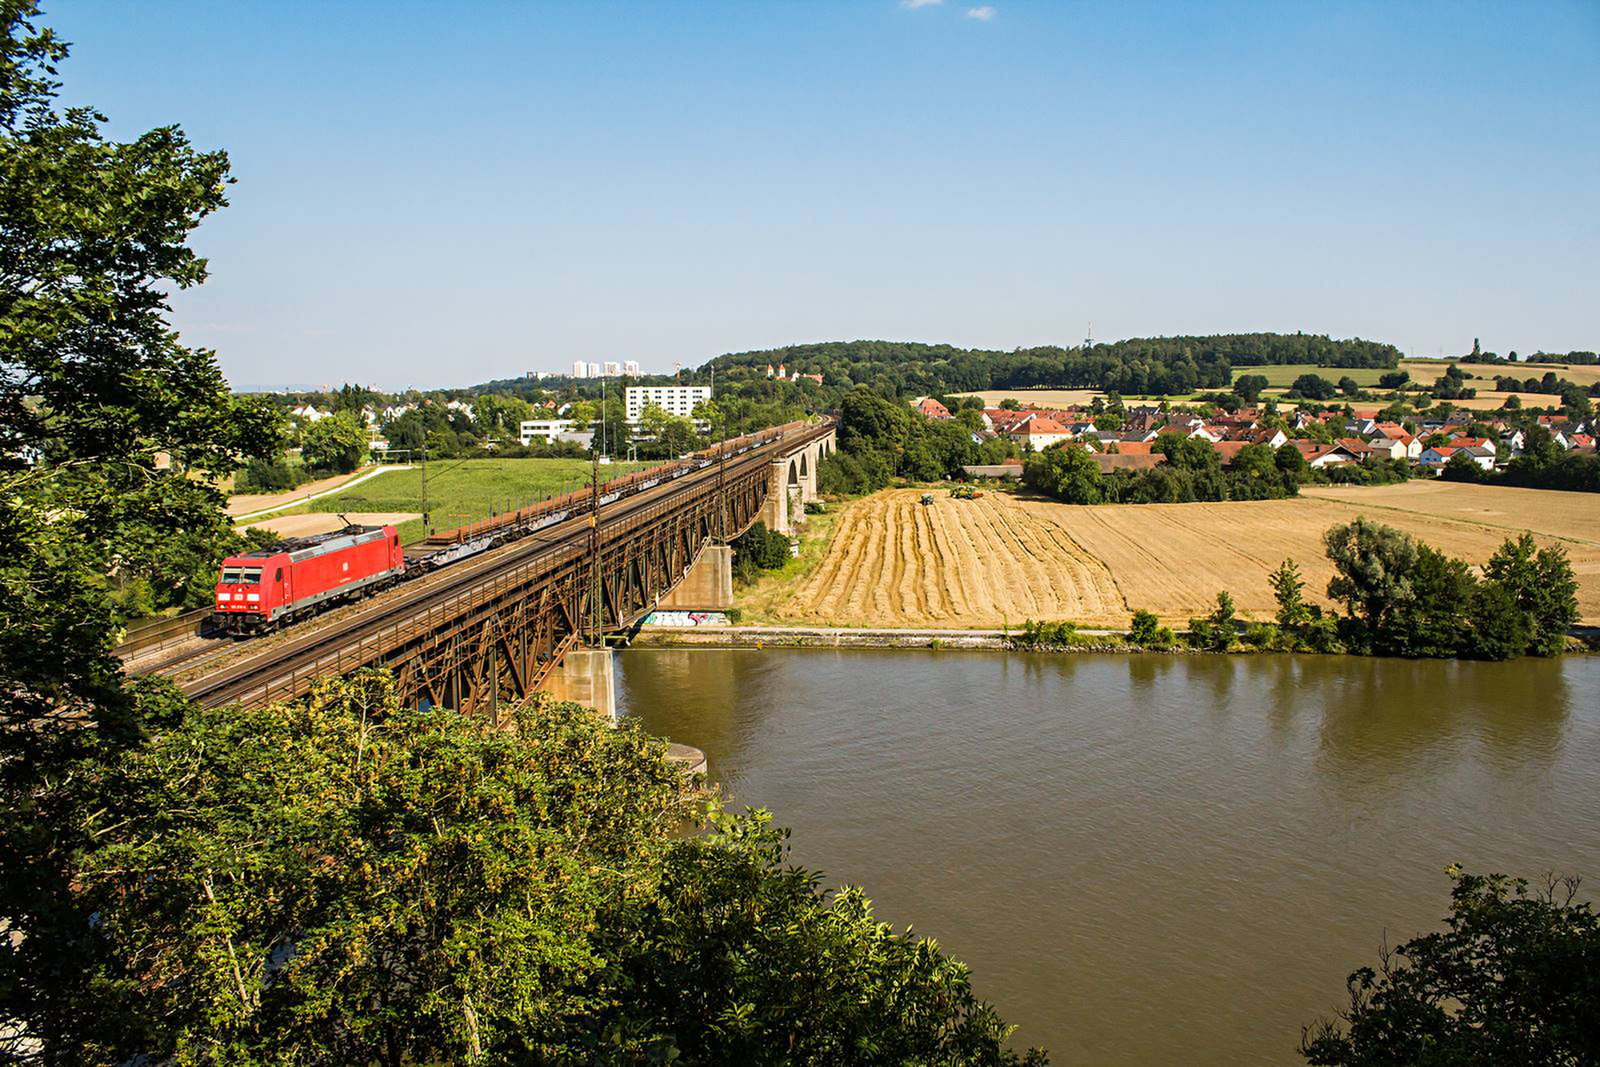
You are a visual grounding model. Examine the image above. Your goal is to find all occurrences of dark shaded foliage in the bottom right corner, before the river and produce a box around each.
[1301,867,1600,1067]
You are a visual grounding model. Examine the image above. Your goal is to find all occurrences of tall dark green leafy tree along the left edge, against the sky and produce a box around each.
[0,0,283,1062]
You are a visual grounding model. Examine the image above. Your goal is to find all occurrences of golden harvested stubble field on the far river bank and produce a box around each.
[776,482,1600,629]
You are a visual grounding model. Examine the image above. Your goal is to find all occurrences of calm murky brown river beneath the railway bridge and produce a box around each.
[618,649,1600,1064]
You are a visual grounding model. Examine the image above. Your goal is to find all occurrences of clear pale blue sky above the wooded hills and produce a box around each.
[45,0,1600,387]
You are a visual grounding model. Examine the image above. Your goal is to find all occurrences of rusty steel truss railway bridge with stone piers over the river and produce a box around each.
[171,418,835,715]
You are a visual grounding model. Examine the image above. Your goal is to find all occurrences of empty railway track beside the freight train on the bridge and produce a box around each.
[172,422,825,707]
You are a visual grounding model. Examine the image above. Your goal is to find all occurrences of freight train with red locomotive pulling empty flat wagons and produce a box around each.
[213,422,805,637]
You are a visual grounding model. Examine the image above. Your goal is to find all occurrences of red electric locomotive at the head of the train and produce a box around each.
[216,526,405,635]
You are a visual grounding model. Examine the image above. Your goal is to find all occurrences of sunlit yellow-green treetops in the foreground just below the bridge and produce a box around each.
[27,672,1043,1064]
